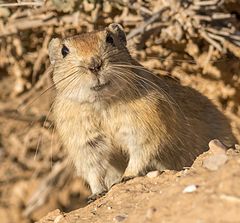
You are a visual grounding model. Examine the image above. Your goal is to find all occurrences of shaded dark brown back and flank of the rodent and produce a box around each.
[150,78,236,169]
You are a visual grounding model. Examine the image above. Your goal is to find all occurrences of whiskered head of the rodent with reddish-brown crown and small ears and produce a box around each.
[49,23,137,102]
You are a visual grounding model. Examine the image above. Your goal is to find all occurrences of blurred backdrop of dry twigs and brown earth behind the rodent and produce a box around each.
[0,0,240,223]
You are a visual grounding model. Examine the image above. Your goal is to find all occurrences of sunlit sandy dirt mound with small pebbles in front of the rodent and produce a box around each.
[39,141,240,223]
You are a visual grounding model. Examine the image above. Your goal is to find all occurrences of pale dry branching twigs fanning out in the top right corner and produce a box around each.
[127,0,240,52]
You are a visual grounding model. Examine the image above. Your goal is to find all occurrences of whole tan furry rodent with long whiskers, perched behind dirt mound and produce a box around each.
[49,24,235,197]
